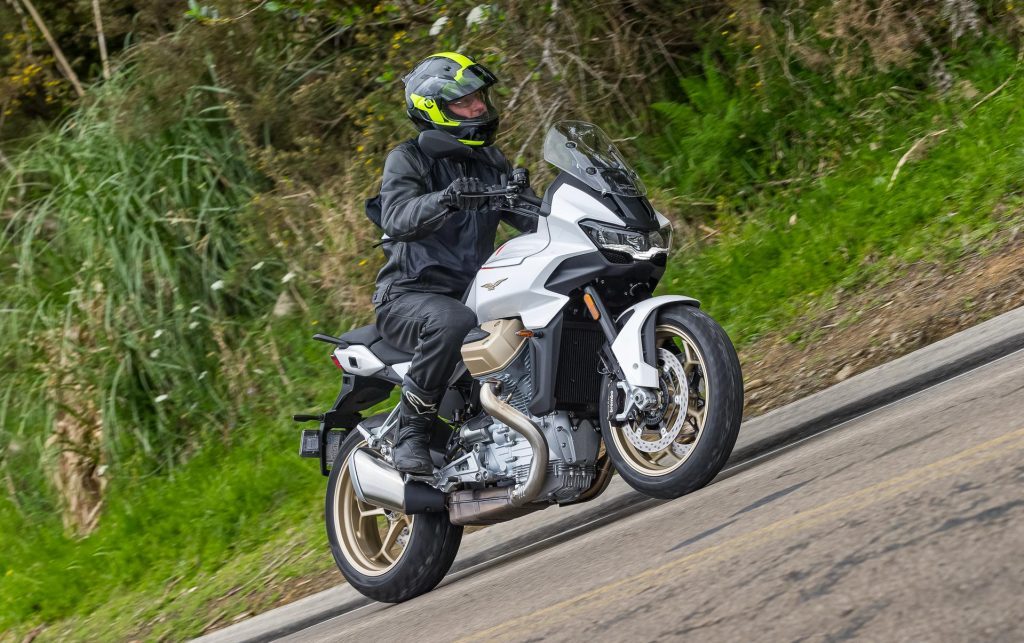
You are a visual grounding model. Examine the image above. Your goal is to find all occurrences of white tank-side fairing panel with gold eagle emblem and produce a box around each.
[467,184,620,329]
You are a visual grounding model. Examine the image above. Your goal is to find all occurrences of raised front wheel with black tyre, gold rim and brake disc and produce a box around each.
[601,306,743,499]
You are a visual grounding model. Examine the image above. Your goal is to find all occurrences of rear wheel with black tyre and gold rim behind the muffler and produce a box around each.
[325,421,463,603]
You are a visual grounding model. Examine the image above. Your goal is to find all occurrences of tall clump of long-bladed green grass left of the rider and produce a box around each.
[0,78,280,487]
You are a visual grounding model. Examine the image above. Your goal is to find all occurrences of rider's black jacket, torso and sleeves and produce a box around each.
[374,139,537,306]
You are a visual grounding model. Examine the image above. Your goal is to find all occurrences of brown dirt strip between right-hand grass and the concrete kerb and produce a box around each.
[740,234,1024,418]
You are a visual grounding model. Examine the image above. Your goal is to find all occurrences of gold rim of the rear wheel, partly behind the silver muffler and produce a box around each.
[333,441,415,576]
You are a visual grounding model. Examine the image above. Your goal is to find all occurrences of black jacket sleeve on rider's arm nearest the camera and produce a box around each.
[381,147,452,242]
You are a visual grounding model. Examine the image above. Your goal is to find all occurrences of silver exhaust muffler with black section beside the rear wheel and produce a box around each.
[348,447,447,516]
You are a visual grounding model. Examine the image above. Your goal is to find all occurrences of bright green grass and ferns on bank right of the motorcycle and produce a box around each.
[658,43,1024,344]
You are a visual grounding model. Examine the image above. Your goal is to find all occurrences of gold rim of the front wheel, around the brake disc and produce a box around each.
[608,325,711,476]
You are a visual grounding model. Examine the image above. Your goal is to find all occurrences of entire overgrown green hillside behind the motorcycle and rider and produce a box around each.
[0,0,1024,640]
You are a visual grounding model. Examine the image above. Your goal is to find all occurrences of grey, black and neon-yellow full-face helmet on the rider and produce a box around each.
[402,51,498,146]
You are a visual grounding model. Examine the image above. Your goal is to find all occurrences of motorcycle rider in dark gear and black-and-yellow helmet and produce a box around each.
[368,52,536,474]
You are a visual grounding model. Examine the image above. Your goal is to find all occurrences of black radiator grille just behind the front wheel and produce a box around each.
[555,323,604,411]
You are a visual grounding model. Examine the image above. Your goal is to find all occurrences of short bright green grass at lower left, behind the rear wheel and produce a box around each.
[0,315,338,628]
